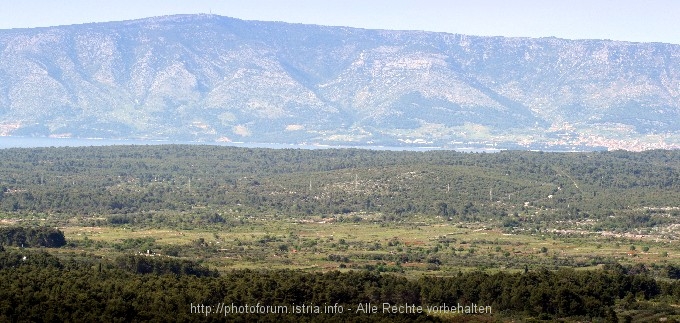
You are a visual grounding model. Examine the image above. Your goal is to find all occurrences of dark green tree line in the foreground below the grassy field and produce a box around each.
[0,248,680,322]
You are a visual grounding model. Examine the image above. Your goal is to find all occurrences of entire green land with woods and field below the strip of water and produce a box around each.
[0,145,680,321]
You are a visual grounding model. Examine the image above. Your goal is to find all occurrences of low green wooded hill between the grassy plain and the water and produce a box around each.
[0,145,680,226]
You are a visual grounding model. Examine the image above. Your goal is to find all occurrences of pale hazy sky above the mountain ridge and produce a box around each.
[0,0,680,44]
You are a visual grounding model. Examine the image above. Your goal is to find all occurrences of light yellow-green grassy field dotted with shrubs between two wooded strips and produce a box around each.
[47,214,680,276]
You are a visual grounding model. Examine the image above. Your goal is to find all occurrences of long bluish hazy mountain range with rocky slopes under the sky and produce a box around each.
[0,15,680,150]
